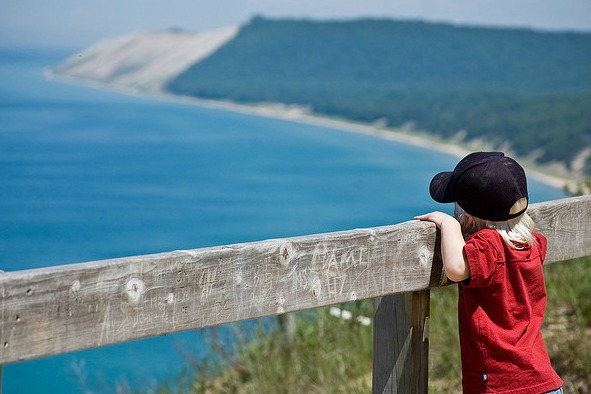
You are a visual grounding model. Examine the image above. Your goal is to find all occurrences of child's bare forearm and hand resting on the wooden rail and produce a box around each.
[415,212,470,282]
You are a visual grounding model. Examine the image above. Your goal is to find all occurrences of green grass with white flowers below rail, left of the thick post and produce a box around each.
[183,301,373,393]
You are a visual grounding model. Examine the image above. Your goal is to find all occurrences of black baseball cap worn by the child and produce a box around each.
[429,152,528,222]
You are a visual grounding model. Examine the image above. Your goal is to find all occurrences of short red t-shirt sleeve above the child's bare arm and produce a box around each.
[464,230,499,287]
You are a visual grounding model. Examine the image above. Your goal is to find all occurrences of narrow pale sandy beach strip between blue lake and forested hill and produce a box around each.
[45,71,576,194]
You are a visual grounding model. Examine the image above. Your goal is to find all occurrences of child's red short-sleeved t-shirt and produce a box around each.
[458,229,562,394]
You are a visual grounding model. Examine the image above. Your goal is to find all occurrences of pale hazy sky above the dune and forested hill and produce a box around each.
[0,0,591,48]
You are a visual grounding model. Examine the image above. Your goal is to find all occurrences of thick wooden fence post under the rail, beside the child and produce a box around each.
[372,290,429,394]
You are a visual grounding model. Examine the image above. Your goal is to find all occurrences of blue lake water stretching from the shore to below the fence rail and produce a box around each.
[0,49,564,393]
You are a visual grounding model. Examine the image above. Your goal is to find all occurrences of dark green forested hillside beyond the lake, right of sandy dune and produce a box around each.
[166,17,591,174]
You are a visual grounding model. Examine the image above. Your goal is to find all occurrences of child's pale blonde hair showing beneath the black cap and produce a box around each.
[454,198,535,249]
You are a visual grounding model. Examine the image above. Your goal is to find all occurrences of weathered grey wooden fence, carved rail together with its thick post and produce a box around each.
[0,196,591,393]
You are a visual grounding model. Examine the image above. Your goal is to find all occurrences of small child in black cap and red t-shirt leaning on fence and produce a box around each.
[415,152,562,394]
